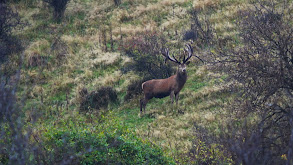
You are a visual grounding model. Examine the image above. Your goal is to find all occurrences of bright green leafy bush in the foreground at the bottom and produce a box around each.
[44,116,175,164]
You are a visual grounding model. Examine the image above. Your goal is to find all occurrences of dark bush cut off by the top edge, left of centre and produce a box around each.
[44,0,70,21]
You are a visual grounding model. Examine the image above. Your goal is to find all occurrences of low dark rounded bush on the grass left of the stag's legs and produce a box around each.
[80,87,118,111]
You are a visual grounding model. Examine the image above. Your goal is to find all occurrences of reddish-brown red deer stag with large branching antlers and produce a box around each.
[140,44,203,114]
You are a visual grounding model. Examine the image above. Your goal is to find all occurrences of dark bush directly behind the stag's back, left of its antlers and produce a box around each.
[121,31,173,78]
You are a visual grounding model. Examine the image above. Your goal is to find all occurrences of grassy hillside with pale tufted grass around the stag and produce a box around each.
[4,0,290,164]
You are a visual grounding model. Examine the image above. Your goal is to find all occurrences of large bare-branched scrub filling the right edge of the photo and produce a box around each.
[212,1,293,164]
